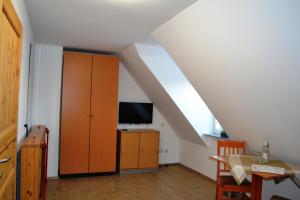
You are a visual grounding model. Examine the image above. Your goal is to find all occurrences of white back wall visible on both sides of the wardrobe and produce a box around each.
[31,44,179,177]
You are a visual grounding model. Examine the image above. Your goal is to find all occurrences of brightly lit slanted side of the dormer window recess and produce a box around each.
[135,44,214,138]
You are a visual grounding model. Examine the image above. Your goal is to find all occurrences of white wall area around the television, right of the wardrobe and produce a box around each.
[118,64,179,164]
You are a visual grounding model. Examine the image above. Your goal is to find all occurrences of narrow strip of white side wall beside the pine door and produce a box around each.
[12,0,34,146]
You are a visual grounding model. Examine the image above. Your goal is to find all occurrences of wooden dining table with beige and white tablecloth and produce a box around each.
[210,155,300,200]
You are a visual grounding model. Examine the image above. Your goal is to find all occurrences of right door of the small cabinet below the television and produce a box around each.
[140,132,159,169]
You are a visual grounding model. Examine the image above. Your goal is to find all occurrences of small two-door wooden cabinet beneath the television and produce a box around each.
[118,129,159,170]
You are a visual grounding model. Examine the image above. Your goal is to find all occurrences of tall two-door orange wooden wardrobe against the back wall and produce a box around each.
[59,51,119,175]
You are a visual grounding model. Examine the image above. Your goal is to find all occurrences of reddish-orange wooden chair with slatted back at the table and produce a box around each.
[216,140,251,200]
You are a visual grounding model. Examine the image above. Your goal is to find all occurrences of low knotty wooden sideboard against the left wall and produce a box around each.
[20,126,48,200]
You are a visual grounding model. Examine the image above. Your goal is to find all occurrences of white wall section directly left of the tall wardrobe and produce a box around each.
[31,44,63,177]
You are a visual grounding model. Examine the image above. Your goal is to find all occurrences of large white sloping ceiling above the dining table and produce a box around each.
[152,0,300,163]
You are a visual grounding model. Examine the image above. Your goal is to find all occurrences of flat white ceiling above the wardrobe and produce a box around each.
[25,0,196,52]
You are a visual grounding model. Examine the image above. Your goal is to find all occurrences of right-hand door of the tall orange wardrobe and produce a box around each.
[89,55,119,173]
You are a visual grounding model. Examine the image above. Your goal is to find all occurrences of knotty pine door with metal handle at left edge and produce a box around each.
[0,0,22,200]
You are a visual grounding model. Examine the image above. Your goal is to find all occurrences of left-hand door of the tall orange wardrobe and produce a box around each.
[58,52,92,175]
